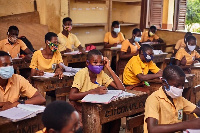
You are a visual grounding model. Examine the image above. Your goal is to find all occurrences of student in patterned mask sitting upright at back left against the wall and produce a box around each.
[58,17,84,53]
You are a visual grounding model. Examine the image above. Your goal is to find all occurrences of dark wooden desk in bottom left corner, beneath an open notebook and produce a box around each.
[0,113,44,133]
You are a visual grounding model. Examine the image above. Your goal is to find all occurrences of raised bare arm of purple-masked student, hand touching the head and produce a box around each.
[104,57,125,90]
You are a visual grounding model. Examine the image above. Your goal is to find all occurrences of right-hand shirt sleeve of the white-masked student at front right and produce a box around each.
[182,97,196,114]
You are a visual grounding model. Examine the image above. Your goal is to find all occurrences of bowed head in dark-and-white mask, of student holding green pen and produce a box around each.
[139,44,154,62]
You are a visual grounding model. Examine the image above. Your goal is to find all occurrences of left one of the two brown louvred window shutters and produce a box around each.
[149,0,163,29]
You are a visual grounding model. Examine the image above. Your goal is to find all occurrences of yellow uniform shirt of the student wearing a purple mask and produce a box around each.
[72,67,113,92]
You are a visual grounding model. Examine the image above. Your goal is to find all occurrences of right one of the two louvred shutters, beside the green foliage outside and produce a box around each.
[177,0,187,30]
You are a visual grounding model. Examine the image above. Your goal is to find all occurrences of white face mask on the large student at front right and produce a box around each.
[164,80,184,98]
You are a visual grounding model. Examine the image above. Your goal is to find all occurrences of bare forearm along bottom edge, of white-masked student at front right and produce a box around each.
[146,117,200,133]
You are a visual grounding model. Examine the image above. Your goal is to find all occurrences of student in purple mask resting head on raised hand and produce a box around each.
[69,50,125,133]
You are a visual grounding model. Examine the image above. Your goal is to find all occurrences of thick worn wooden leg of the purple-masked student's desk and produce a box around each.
[82,103,102,133]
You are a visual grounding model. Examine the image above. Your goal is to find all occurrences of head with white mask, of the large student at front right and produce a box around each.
[162,65,185,98]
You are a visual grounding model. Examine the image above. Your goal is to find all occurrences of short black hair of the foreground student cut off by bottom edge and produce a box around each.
[42,101,75,131]
